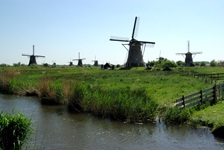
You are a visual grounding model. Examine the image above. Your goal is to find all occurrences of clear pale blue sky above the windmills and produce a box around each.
[0,0,224,65]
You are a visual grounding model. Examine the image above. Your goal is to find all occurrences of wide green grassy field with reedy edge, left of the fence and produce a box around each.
[0,67,220,122]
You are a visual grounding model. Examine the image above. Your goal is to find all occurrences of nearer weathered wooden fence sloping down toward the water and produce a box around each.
[175,82,224,108]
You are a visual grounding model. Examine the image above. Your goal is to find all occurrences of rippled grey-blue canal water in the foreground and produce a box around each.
[0,95,224,150]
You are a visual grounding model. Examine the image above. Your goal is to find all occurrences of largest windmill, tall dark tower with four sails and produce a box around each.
[110,17,155,68]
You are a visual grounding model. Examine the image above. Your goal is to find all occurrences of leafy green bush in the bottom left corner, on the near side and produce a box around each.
[0,112,32,150]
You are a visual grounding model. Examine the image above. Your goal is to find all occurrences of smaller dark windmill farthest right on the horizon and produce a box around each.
[176,41,202,66]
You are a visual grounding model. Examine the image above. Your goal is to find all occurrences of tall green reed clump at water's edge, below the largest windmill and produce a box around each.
[68,83,158,122]
